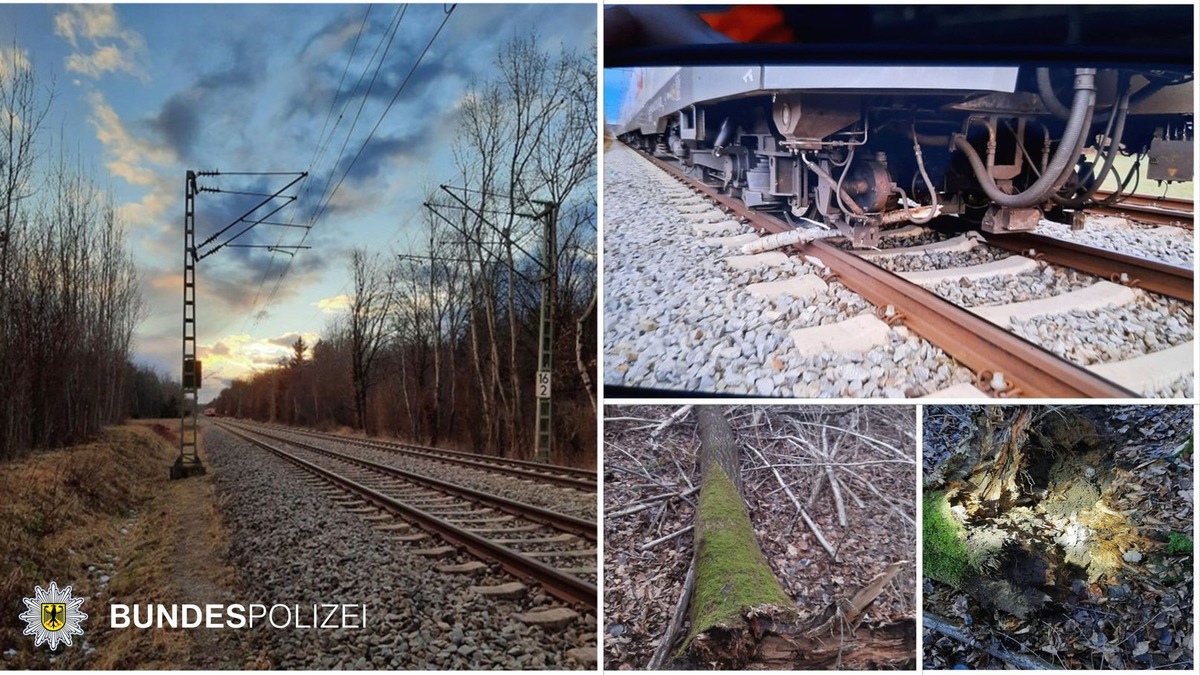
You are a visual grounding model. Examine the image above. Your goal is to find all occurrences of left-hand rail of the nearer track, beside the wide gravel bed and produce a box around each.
[220,424,599,611]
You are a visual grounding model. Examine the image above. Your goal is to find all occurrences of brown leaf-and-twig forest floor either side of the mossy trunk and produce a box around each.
[604,406,917,670]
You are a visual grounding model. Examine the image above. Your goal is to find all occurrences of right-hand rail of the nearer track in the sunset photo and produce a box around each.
[218,422,596,542]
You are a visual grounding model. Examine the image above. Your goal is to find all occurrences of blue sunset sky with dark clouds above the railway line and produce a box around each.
[0,4,596,401]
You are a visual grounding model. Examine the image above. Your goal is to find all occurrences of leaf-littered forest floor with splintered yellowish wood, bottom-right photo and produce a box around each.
[923,406,1194,669]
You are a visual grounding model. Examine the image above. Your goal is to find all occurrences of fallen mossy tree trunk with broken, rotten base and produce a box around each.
[683,406,916,669]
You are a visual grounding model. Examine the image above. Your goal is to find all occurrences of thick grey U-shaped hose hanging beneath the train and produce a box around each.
[954,68,1096,208]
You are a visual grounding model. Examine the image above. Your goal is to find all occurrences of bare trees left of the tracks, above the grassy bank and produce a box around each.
[0,52,161,460]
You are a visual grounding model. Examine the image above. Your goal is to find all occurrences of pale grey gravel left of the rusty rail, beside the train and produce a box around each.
[604,145,973,398]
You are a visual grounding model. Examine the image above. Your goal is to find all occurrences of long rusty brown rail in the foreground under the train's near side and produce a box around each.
[642,147,1140,399]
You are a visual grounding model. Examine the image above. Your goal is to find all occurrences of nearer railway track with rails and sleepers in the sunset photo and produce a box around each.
[215,420,598,607]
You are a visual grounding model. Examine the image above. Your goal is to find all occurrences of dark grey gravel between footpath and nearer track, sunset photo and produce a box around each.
[204,425,596,670]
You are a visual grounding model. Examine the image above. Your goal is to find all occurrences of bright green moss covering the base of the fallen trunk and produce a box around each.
[684,466,793,649]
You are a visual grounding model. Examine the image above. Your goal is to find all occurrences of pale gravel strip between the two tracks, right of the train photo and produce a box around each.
[1038,216,1195,269]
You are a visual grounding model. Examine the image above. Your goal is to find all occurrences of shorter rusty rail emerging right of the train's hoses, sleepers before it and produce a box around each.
[984,233,1195,303]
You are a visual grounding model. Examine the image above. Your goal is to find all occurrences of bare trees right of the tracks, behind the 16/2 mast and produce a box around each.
[214,35,598,465]
